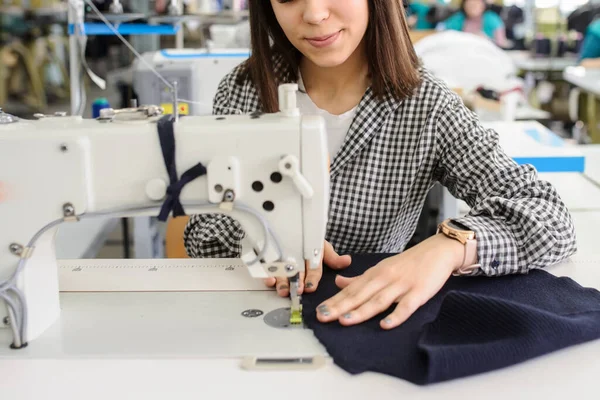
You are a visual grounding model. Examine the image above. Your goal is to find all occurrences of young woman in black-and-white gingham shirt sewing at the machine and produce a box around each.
[184,0,576,329]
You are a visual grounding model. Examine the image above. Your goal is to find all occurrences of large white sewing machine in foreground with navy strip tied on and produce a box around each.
[0,85,329,348]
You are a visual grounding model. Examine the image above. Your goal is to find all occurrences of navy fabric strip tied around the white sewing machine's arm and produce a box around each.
[156,115,206,222]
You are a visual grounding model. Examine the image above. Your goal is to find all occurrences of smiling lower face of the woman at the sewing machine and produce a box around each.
[271,0,369,67]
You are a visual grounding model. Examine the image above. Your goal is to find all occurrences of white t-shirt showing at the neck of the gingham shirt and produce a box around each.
[297,75,357,162]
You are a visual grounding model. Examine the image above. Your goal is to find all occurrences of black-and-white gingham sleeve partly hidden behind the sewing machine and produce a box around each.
[183,73,245,258]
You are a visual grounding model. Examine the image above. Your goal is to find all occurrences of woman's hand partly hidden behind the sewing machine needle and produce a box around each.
[265,241,352,297]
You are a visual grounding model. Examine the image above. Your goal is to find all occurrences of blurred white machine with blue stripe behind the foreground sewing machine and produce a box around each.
[132,49,250,115]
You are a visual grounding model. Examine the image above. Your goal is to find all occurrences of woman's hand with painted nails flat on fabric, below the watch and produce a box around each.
[317,234,465,329]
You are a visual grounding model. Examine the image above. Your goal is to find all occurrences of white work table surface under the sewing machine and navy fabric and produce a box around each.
[0,255,600,400]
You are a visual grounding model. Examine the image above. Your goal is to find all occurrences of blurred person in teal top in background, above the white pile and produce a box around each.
[442,0,507,47]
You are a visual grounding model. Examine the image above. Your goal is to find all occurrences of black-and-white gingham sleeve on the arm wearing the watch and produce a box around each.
[436,93,576,276]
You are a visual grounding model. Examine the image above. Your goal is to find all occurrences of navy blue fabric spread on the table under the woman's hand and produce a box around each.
[303,254,600,385]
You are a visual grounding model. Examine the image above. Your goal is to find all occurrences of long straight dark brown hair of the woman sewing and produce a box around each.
[240,0,420,112]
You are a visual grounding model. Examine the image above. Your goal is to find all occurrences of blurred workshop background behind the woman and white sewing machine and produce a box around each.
[0,0,600,259]
